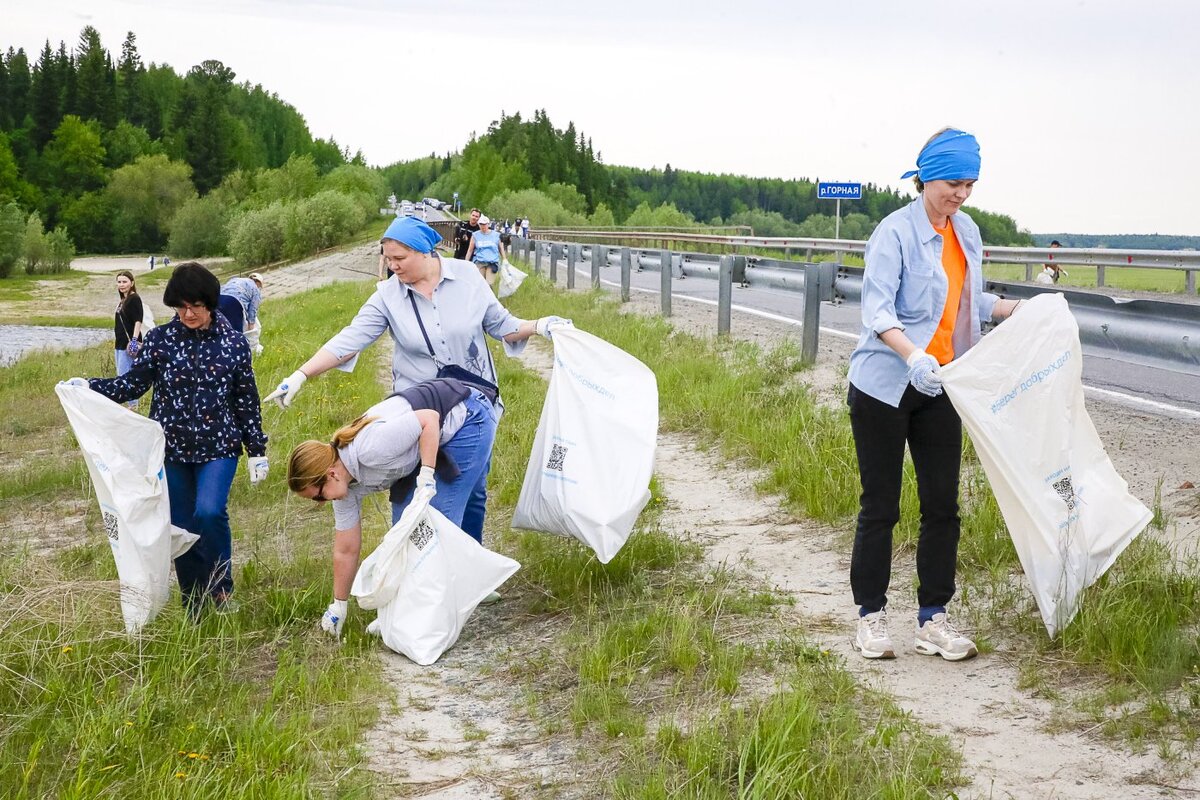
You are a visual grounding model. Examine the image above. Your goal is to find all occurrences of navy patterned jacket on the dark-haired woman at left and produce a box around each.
[88,313,266,464]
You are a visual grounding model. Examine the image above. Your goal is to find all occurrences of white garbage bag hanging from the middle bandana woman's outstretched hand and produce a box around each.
[512,327,659,564]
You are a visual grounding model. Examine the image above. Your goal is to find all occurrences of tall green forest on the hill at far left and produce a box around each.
[0,25,374,271]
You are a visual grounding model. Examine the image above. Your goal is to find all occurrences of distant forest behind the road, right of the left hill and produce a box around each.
[384,110,1033,245]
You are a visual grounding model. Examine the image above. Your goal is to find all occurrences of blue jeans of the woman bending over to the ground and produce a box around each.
[391,389,498,545]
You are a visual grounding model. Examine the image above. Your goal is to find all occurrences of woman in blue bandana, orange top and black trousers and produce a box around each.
[847,128,1018,661]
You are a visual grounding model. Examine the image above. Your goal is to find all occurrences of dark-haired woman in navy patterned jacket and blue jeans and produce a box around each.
[80,261,268,615]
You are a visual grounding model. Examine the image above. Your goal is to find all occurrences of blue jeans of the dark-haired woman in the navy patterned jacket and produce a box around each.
[163,458,238,614]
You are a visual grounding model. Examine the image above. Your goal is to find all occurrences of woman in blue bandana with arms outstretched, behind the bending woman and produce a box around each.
[263,217,570,633]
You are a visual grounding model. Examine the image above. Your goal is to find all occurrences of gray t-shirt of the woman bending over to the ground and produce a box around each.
[334,397,467,530]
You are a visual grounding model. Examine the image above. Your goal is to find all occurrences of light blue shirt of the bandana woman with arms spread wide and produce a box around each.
[324,257,526,391]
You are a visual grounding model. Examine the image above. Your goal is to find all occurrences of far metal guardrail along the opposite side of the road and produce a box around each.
[533,228,1200,294]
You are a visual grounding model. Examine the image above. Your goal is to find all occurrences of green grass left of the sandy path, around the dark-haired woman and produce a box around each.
[0,280,396,798]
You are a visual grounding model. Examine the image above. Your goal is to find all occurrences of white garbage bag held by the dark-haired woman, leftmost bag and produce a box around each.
[55,384,198,633]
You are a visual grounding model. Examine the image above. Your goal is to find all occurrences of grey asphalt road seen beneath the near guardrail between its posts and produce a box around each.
[559,255,1200,420]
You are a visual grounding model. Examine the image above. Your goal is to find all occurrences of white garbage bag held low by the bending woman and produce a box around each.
[350,501,521,667]
